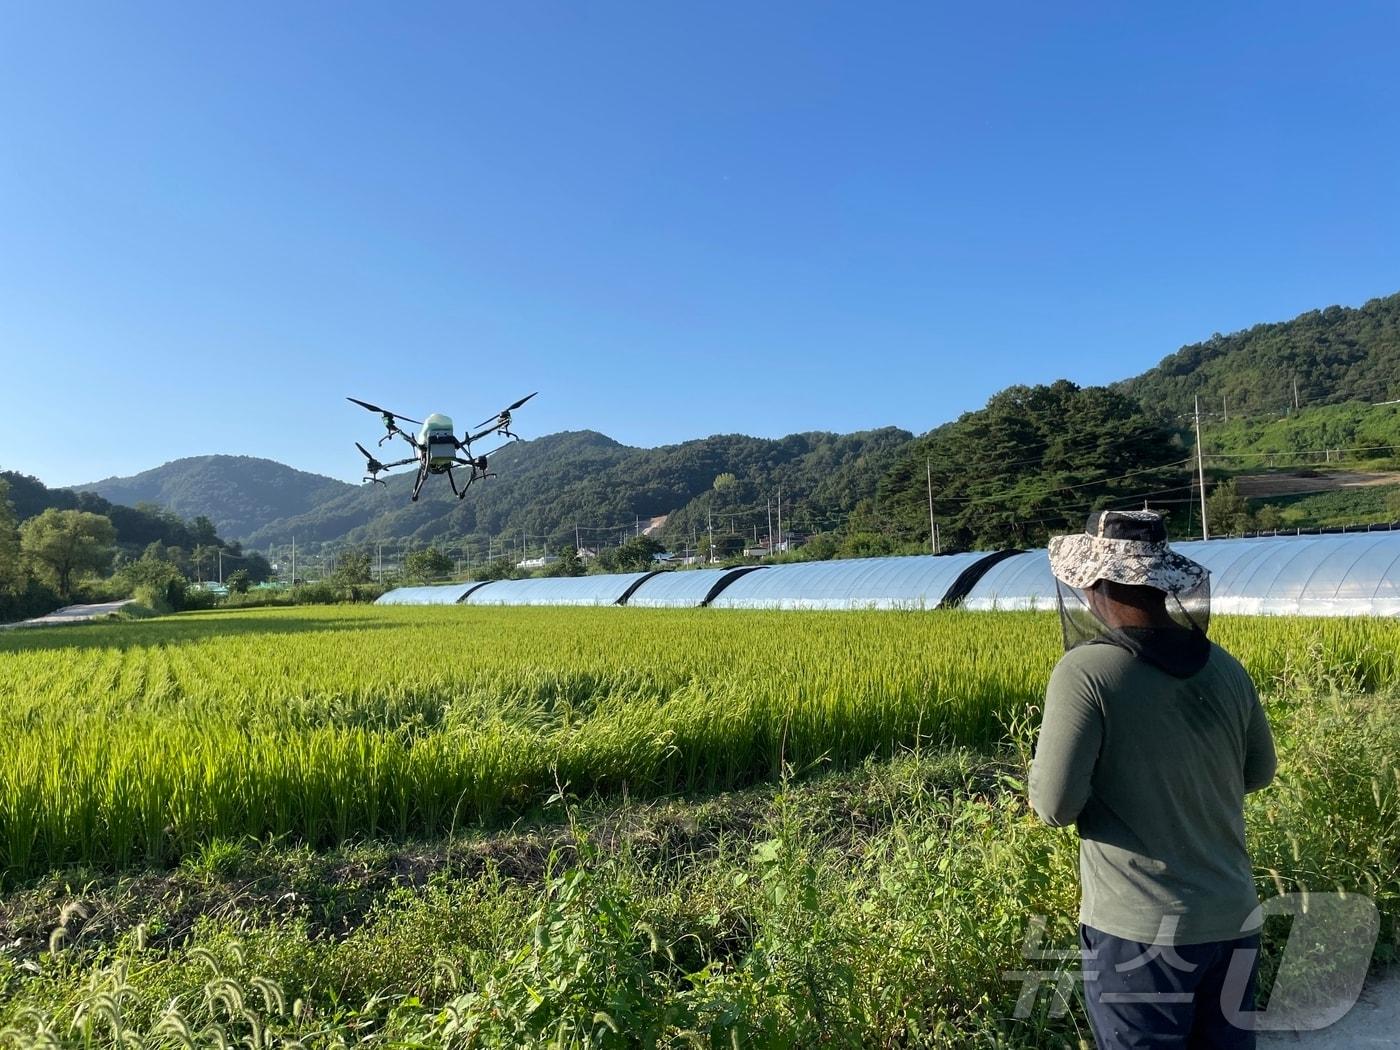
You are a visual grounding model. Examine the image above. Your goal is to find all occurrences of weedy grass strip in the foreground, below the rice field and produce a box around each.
[0,687,1400,1047]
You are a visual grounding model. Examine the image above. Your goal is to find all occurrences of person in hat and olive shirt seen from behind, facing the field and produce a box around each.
[1030,511,1277,1050]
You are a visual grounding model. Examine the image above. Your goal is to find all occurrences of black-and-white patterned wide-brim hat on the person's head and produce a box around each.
[1050,511,1211,595]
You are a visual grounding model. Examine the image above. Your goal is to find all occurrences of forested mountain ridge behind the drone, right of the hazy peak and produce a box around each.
[240,427,913,553]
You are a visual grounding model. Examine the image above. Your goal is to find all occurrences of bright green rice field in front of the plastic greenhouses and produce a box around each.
[0,608,1400,882]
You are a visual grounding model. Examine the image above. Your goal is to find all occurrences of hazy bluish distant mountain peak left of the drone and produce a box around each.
[73,455,357,539]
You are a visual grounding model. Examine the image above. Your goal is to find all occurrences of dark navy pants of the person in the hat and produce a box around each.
[1079,925,1259,1050]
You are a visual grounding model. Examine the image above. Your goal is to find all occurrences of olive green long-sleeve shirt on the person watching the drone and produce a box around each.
[1030,644,1275,944]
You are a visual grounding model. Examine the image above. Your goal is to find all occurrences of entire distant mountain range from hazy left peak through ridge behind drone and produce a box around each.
[77,427,913,553]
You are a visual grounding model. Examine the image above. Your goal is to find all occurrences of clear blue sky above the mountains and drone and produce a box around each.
[0,3,1400,484]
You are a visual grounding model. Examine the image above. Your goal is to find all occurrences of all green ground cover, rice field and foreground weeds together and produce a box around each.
[0,608,1400,1047]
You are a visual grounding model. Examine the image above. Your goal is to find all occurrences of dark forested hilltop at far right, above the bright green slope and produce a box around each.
[1117,293,1400,416]
